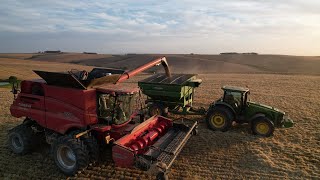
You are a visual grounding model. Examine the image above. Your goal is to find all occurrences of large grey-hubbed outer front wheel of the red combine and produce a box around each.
[52,136,89,176]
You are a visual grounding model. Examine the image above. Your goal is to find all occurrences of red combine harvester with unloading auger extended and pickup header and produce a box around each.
[8,57,197,178]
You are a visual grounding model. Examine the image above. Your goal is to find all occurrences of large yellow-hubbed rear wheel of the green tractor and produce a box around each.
[206,107,233,132]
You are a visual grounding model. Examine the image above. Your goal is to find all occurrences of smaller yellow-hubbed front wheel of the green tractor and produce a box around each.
[252,117,274,137]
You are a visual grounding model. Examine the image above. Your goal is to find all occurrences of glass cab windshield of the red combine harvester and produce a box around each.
[99,94,135,124]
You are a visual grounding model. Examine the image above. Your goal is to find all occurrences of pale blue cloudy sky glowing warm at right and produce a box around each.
[0,0,320,55]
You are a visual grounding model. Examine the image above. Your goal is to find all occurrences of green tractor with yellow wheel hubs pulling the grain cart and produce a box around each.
[206,86,293,137]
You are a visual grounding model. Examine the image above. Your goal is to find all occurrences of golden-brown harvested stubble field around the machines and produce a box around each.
[0,74,320,179]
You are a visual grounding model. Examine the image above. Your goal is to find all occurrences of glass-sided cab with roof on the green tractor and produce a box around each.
[222,86,250,113]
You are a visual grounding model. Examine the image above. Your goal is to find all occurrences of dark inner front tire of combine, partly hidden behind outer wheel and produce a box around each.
[80,134,100,163]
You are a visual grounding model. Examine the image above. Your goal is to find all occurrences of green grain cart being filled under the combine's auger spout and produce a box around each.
[138,74,205,116]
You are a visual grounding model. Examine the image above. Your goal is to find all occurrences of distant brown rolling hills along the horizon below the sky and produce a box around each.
[0,53,320,75]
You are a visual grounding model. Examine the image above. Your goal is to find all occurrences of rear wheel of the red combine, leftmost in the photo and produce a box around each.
[8,124,35,154]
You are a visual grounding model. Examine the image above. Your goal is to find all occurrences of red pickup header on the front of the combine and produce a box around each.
[112,116,197,177]
